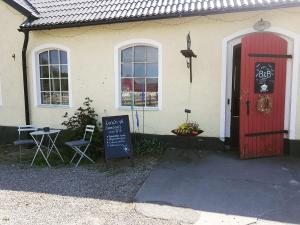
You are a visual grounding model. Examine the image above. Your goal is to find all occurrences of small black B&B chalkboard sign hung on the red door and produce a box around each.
[255,62,275,93]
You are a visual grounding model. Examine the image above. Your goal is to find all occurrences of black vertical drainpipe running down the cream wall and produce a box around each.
[21,30,30,125]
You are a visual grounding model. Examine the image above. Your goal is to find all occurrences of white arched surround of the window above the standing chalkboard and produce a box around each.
[114,39,162,111]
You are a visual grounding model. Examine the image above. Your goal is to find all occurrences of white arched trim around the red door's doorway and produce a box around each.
[220,27,300,140]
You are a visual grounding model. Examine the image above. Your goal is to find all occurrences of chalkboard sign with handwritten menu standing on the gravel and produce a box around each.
[102,115,133,160]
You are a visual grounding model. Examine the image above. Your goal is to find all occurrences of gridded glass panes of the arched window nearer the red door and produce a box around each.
[120,45,159,108]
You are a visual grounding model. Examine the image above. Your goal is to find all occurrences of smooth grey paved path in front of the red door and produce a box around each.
[135,150,300,225]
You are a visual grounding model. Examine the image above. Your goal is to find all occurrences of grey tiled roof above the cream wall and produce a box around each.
[7,0,300,30]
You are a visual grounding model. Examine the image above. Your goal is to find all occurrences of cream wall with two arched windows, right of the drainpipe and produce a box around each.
[0,8,300,139]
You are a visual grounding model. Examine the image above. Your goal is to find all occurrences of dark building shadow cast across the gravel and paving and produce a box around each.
[0,145,300,225]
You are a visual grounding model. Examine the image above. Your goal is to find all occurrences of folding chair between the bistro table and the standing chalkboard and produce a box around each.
[65,125,95,167]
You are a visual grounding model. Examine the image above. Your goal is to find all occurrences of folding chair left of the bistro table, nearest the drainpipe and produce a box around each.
[14,125,37,162]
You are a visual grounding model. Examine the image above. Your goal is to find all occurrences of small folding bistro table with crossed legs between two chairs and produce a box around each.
[30,129,64,167]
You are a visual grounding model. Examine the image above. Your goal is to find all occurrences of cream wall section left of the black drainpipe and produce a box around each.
[0,1,26,126]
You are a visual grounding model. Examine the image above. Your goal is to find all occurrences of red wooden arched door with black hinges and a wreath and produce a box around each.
[240,33,288,159]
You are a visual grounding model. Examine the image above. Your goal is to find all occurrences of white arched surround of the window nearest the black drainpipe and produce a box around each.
[32,44,72,108]
